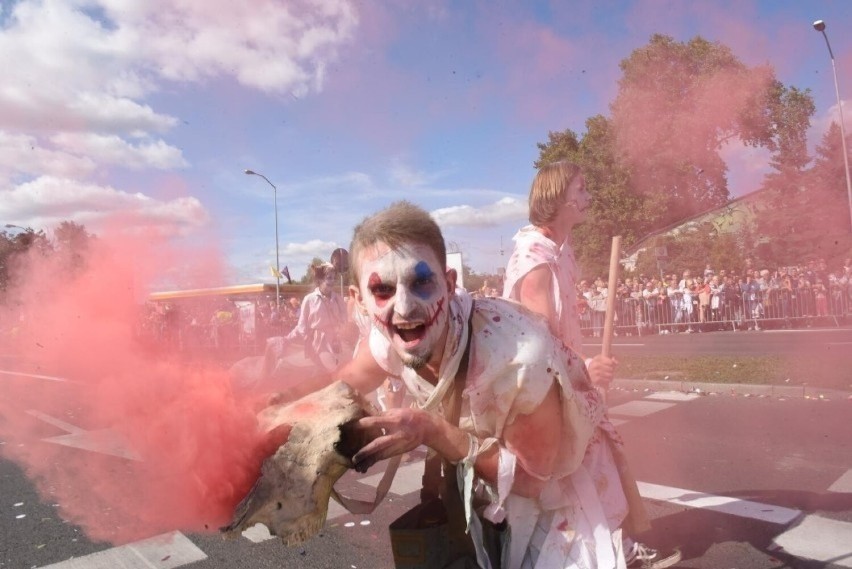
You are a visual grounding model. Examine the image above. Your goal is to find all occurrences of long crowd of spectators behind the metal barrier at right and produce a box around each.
[577,259,852,336]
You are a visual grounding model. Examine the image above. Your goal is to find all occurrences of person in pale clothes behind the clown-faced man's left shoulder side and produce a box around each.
[265,263,351,374]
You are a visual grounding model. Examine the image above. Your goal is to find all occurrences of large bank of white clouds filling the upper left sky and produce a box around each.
[0,0,358,245]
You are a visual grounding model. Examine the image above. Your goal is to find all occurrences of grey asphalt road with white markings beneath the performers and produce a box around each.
[0,356,852,569]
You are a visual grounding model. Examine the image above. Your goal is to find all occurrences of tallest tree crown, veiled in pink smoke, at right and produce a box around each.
[612,34,813,225]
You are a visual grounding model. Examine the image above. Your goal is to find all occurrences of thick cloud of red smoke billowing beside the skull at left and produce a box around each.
[0,220,268,543]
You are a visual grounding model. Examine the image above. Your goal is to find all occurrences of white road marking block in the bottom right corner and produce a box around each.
[773,515,852,567]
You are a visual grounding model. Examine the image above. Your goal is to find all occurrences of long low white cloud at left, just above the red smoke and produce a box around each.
[0,176,209,235]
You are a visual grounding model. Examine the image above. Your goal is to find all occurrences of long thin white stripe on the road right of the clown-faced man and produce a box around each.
[637,482,802,524]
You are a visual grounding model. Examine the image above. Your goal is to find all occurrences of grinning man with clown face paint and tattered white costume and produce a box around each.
[335,202,627,569]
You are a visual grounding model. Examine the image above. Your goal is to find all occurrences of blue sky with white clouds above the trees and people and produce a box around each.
[0,0,852,286]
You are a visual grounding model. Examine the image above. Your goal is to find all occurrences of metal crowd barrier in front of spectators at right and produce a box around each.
[580,289,852,336]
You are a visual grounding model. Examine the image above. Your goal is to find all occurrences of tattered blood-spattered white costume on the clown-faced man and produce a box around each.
[369,291,627,569]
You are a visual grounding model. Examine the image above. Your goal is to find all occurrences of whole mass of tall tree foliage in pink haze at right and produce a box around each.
[535,34,814,275]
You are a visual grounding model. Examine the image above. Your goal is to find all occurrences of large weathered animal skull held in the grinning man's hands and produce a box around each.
[221,382,372,546]
